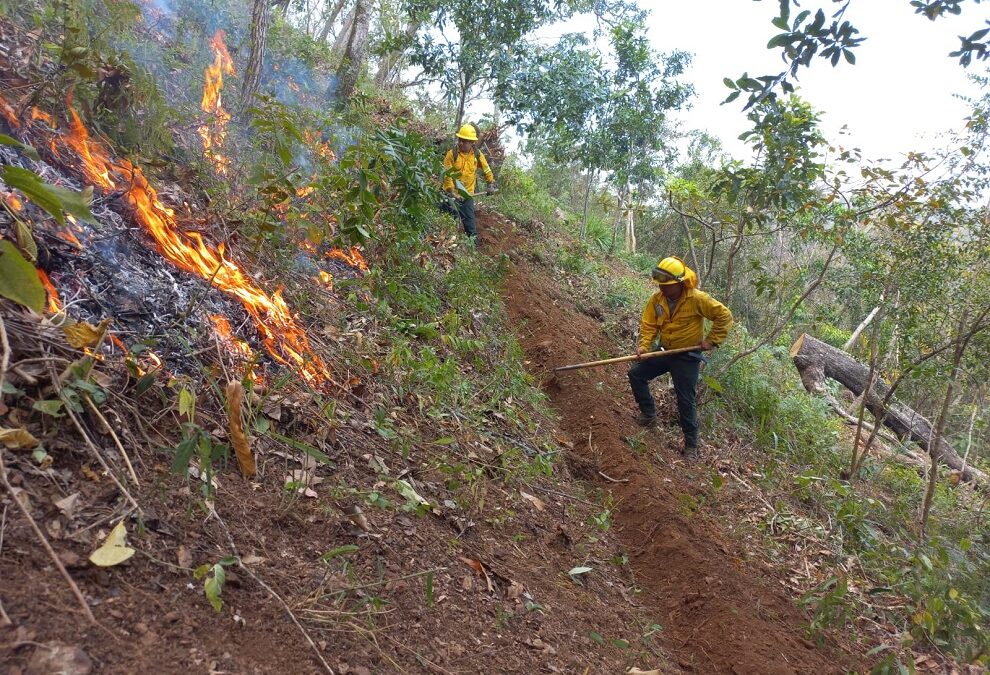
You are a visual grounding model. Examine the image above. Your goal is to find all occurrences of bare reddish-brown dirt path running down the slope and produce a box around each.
[478,213,855,674]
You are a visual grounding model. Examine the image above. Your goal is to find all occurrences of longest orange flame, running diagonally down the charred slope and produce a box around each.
[65,100,329,384]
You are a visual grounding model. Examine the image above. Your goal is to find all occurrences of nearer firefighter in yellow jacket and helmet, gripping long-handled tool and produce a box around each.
[629,256,732,459]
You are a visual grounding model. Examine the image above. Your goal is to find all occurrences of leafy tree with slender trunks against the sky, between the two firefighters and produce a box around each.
[498,13,693,244]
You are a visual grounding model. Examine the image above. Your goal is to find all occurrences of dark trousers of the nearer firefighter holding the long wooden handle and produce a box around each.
[629,352,702,447]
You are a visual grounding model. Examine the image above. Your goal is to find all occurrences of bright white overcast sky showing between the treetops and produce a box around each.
[474,0,990,160]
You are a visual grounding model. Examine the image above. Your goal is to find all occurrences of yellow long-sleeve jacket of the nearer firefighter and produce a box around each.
[639,288,732,351]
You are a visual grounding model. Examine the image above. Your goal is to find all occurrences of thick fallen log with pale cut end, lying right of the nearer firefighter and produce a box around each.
[791,334,990,487]
